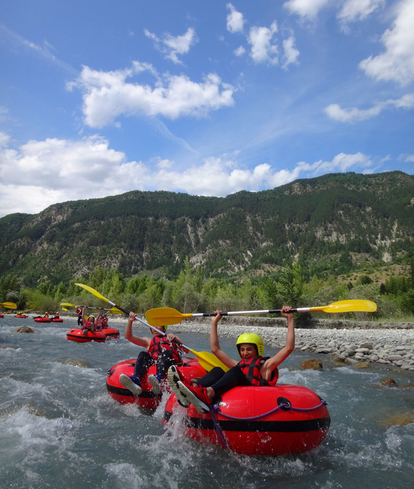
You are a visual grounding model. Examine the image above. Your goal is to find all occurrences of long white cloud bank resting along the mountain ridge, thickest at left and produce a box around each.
[0,136,371,216]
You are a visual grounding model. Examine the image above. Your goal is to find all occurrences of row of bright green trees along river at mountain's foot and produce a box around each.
[0,258,414,322]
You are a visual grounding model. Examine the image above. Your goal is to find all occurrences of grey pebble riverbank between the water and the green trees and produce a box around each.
[12,314,414,371]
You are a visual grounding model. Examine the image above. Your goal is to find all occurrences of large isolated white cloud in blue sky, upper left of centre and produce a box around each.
[68,62,235,128]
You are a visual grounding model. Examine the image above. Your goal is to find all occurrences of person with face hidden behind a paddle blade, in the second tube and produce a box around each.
[119,312,188,396]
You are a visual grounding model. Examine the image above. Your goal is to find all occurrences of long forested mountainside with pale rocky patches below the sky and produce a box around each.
[0,172,414,286]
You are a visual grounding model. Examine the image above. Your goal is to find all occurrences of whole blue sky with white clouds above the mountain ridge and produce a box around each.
[0,0,414,217]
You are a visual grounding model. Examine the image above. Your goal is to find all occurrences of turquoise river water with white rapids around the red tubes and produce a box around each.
[0,316,414,489]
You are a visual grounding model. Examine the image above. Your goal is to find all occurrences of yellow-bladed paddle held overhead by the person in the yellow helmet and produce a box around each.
[145,300,377,326]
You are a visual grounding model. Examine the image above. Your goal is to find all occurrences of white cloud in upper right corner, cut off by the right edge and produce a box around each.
[359,0,414,85]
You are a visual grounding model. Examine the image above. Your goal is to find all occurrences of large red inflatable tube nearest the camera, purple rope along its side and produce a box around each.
[163,384,330,456]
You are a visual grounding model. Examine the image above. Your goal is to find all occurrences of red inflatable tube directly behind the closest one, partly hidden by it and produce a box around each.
[106,358,206,409]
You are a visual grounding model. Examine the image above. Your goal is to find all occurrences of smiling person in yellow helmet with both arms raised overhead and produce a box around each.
[168,306,295,413]
